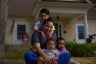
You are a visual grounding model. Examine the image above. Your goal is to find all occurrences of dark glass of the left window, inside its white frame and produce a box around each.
[17,25,26,39]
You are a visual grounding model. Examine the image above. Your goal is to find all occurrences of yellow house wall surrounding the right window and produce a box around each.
[63,18,96,42]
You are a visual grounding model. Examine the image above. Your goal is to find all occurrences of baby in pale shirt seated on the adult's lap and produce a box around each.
[37,39,58,64]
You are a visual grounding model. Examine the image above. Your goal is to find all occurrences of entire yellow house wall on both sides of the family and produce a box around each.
[5,17,96,44]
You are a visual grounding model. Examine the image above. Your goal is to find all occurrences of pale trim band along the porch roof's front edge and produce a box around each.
[32,2,89,16]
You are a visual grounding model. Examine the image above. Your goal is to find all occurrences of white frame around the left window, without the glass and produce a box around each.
[13,19,30,45]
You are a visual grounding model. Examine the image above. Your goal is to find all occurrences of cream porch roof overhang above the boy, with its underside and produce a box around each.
[32,1,91,18]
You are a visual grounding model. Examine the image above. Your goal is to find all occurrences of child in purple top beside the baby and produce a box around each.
[57,38,79,64]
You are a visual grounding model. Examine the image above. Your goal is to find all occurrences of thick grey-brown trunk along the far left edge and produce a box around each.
[0,0,8,64]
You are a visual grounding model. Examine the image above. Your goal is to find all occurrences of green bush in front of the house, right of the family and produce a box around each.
[65,43,96,57]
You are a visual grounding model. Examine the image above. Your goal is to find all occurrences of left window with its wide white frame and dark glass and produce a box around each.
[13,19,30,45]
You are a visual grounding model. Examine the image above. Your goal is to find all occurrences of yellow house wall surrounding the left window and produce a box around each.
[5,16,34,45]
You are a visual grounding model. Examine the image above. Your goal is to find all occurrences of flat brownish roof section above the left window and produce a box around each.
[8,0,37,16]
